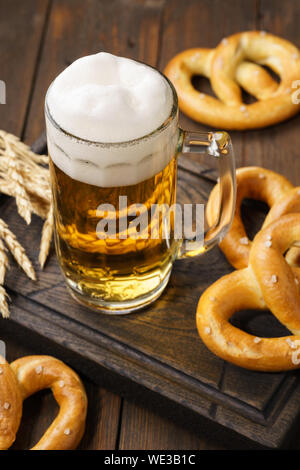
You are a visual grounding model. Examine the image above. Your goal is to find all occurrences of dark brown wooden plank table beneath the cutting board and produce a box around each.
[0,0,300,450]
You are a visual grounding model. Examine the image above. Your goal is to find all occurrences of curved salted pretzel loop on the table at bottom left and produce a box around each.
[9,356,87,450]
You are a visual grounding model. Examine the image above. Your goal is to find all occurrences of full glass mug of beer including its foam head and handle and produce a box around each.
[45,53,235,313]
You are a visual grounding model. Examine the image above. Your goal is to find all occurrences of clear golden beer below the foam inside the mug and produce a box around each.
[50,158,178,309]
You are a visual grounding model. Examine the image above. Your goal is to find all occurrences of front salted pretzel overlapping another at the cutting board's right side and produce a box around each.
[196,214,300,371]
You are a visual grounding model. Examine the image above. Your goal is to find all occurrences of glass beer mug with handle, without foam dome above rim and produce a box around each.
[45,56,236,314]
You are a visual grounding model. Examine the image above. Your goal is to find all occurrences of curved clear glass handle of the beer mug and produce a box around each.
[177,129,236,258]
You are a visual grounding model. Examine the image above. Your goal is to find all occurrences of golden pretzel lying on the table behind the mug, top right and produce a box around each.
[164,31,300,130]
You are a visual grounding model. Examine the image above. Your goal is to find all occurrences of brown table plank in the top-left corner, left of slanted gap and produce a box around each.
[0,0,50,136]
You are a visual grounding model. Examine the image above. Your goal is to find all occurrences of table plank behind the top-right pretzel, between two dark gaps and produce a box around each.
[158,0,257,171]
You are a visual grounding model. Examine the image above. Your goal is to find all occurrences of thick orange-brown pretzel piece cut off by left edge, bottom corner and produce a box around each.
[0,356,22,450]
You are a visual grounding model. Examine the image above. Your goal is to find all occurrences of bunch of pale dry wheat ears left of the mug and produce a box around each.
[0,130,53,318]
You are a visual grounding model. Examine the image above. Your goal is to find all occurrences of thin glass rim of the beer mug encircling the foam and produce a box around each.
[45,59,178,147]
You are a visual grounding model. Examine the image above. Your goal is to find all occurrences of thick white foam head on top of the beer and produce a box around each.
[46,52,178,187]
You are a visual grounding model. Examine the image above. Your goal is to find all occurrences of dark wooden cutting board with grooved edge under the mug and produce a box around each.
[0,136,300,448]
